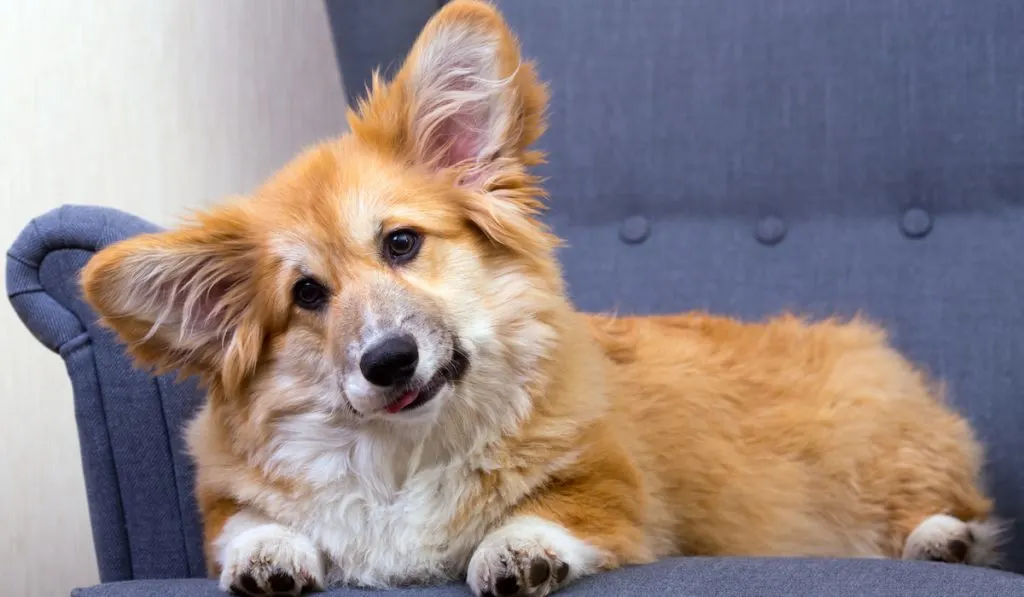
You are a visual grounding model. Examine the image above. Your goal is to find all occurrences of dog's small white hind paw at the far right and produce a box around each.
[902,514,1000,566]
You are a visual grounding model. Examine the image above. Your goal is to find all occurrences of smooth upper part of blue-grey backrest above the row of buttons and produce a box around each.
[498,0,1024,223]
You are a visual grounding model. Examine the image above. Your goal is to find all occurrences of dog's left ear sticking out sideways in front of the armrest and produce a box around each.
[82,206,262,393]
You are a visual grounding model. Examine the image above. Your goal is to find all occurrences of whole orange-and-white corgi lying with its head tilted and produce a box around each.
[82,0,998,597]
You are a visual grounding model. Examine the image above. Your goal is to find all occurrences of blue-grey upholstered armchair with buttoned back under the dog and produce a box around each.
[7,0,1024,597]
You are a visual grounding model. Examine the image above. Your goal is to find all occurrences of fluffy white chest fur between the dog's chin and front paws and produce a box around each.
[241,420,577,587]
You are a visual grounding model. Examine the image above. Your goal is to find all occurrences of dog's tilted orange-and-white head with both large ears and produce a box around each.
[83,1,563,448]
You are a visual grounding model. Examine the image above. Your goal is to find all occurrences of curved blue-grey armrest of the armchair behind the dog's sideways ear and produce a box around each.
[7,206,204,582]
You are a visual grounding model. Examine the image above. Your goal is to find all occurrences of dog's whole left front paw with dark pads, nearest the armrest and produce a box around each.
[220,523,324,597]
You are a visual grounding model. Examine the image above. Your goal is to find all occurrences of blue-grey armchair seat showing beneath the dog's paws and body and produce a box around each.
[73,558,1024,597]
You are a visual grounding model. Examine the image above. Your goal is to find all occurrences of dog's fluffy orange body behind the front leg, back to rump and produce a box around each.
[591,314,994,562]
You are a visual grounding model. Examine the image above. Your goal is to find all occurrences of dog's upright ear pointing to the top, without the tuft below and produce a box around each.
[349,0,547,185]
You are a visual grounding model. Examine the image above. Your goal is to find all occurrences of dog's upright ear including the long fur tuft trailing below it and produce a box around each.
[349,0,557,258]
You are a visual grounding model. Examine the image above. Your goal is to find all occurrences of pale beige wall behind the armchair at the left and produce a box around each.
[0,0,344,597]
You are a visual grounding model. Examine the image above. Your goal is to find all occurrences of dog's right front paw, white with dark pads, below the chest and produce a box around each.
[466,516,600,597]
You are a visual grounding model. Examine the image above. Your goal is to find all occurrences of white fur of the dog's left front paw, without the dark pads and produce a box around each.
[214,510,325,591]
